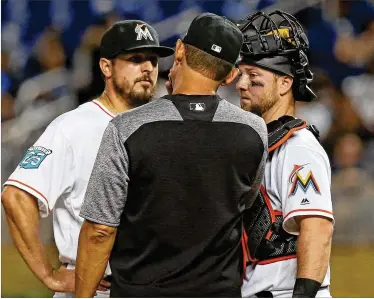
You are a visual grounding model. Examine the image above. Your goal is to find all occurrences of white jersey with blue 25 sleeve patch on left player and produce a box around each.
[4,100,114,297]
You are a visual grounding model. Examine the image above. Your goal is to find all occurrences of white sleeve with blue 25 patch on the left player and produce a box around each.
[4,122,74,217]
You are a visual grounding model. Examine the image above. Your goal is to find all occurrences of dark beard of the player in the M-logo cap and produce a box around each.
[113,75,156,108]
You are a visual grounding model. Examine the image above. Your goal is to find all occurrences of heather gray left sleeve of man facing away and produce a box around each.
[80,122,129,227]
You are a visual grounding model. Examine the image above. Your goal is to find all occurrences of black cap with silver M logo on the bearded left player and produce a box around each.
[100,20,174,59]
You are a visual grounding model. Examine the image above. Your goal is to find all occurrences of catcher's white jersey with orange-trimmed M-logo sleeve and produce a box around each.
[242,129,333,298]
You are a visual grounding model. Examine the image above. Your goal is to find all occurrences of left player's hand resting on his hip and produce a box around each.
[44,265,75,292]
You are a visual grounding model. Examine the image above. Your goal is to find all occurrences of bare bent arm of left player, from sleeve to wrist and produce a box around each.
[2,187,53,287]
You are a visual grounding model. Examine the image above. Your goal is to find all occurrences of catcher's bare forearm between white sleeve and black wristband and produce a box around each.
[296,217,333,283]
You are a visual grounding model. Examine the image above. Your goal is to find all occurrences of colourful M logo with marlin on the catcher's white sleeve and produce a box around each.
[288,164,321,197]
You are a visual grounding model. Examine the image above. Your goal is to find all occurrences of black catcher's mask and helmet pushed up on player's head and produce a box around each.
[238,10,316,102]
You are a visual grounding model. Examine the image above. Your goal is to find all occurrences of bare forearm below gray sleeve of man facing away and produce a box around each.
[75,221,116,297]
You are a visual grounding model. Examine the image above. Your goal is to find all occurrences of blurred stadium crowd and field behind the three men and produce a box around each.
[1,0,374,297]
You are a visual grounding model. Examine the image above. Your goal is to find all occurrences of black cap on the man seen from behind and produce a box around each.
[183,13,243,64]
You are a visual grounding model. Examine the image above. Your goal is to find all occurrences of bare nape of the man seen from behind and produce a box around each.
[173,66,218,95]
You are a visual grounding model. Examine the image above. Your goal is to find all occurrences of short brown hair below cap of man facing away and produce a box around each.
[183,43,234,81]
